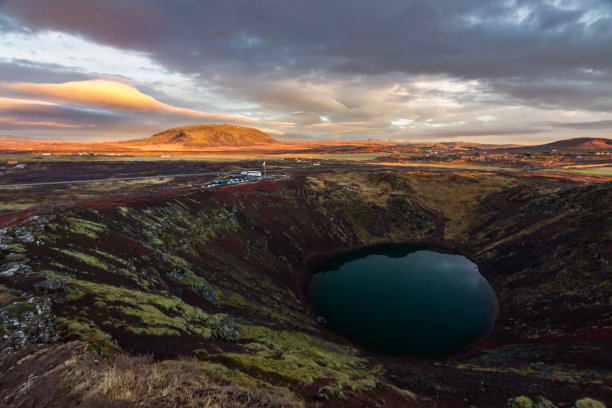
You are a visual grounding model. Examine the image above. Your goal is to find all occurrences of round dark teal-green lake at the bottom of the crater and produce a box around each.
[308,246,499,356]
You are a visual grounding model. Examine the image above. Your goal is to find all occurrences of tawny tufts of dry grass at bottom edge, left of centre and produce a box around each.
[68,354,303,408]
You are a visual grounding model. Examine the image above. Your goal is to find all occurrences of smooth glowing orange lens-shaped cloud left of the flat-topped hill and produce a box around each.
[0,79,256,123]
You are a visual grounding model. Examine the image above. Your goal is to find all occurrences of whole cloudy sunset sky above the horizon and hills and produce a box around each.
[0,0,612,144]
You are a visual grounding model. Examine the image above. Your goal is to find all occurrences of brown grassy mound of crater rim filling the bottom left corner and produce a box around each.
[0,341,302,408]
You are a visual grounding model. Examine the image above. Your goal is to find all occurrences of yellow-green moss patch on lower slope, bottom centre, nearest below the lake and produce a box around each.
[218,325,380,397]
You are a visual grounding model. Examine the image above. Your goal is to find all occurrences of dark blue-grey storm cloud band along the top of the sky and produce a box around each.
[0,0,612,78]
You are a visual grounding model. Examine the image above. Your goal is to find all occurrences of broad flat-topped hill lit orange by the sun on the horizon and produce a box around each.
[125,125,278,147]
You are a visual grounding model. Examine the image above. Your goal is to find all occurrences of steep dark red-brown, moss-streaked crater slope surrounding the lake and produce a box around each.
[0,173,612,406]
